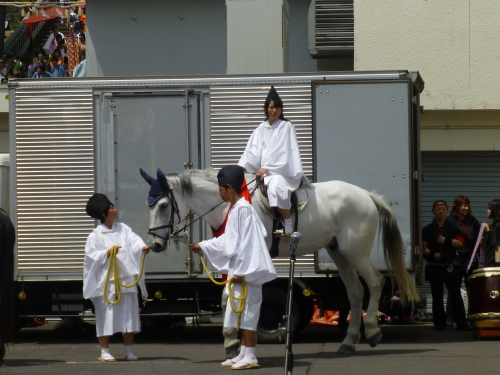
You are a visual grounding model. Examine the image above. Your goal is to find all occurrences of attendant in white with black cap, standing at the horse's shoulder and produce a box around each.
[190,165,276,370]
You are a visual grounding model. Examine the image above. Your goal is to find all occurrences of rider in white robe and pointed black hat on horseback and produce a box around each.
[238,86,309,236]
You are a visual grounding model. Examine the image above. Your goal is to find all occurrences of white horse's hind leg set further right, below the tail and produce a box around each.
[351,257,385,348]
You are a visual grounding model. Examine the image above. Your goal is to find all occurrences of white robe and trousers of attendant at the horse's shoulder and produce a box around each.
[200,198,276,331]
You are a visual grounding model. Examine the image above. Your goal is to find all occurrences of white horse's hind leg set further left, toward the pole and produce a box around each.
[327,249,364,354]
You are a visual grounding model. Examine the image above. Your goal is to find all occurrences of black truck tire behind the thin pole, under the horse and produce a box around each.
[257,286,300,344]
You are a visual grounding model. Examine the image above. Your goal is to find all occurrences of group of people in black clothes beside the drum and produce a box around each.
[422,195,500,330]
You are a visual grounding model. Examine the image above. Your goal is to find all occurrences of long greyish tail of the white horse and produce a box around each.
[368,193,420,304]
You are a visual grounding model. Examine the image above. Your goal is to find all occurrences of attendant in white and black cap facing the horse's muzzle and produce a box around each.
[83,194,149,362]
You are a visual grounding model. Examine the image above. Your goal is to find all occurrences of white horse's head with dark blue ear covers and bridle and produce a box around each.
[141,168,178,253]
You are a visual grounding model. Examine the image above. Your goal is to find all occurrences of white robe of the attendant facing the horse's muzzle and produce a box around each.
[83,222,147,337]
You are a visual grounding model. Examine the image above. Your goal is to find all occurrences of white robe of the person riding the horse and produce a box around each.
[238,119,309,209]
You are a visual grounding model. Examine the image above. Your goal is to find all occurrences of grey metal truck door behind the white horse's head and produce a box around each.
[97,91,201,278]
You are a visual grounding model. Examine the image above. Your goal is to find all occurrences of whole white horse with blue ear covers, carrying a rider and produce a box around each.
[141,169,418,354]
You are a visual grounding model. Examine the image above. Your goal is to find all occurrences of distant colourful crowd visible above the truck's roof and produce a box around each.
[0,25,86,84]
